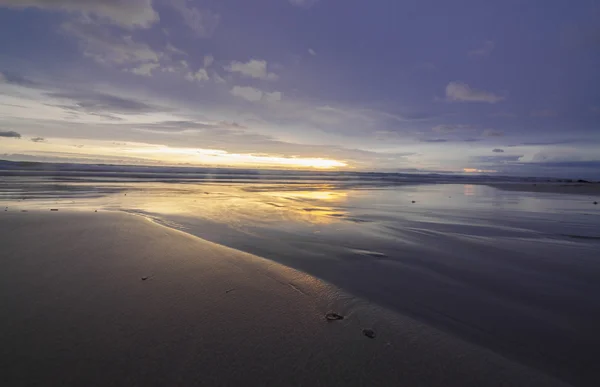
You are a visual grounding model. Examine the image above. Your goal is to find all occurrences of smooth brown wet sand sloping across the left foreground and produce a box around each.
[0,210,565,387]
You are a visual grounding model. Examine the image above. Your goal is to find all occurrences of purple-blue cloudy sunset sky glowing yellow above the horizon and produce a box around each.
[0,0,600,177]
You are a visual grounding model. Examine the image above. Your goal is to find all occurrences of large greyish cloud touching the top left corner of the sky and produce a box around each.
[0,0,159,28]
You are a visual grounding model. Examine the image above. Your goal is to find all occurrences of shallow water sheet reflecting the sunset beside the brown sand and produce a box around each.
[0,177,600,386]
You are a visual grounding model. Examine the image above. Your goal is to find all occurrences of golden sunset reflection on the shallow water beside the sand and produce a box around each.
[104,183,349,232]
